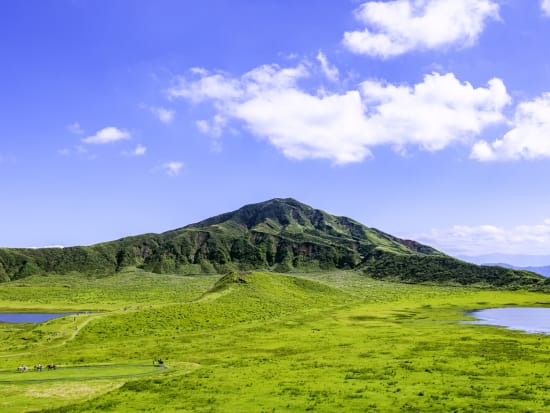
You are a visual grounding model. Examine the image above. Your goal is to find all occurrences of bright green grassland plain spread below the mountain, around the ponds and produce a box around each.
[0,269,550,412]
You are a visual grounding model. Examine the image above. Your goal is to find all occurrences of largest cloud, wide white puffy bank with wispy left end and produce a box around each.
[169,63,510,164]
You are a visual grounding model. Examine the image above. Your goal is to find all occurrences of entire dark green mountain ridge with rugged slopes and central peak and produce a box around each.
[0,199,544,286]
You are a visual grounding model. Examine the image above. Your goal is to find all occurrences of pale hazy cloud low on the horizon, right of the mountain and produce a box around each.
[412,219,550,256]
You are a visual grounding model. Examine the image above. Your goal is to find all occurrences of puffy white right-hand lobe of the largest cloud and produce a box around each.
[361,73,510,151]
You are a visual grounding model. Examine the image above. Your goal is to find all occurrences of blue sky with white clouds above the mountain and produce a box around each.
[0,0,550,255]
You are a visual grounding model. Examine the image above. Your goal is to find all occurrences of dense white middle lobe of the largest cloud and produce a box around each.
[237,89,374,164]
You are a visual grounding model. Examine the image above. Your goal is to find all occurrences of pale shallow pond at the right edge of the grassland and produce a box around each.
[468,307,550,334]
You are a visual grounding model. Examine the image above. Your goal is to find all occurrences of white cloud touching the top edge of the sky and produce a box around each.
[343,0,499,58]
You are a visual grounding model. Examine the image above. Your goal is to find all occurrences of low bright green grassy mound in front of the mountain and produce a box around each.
[70,272,351,348]
